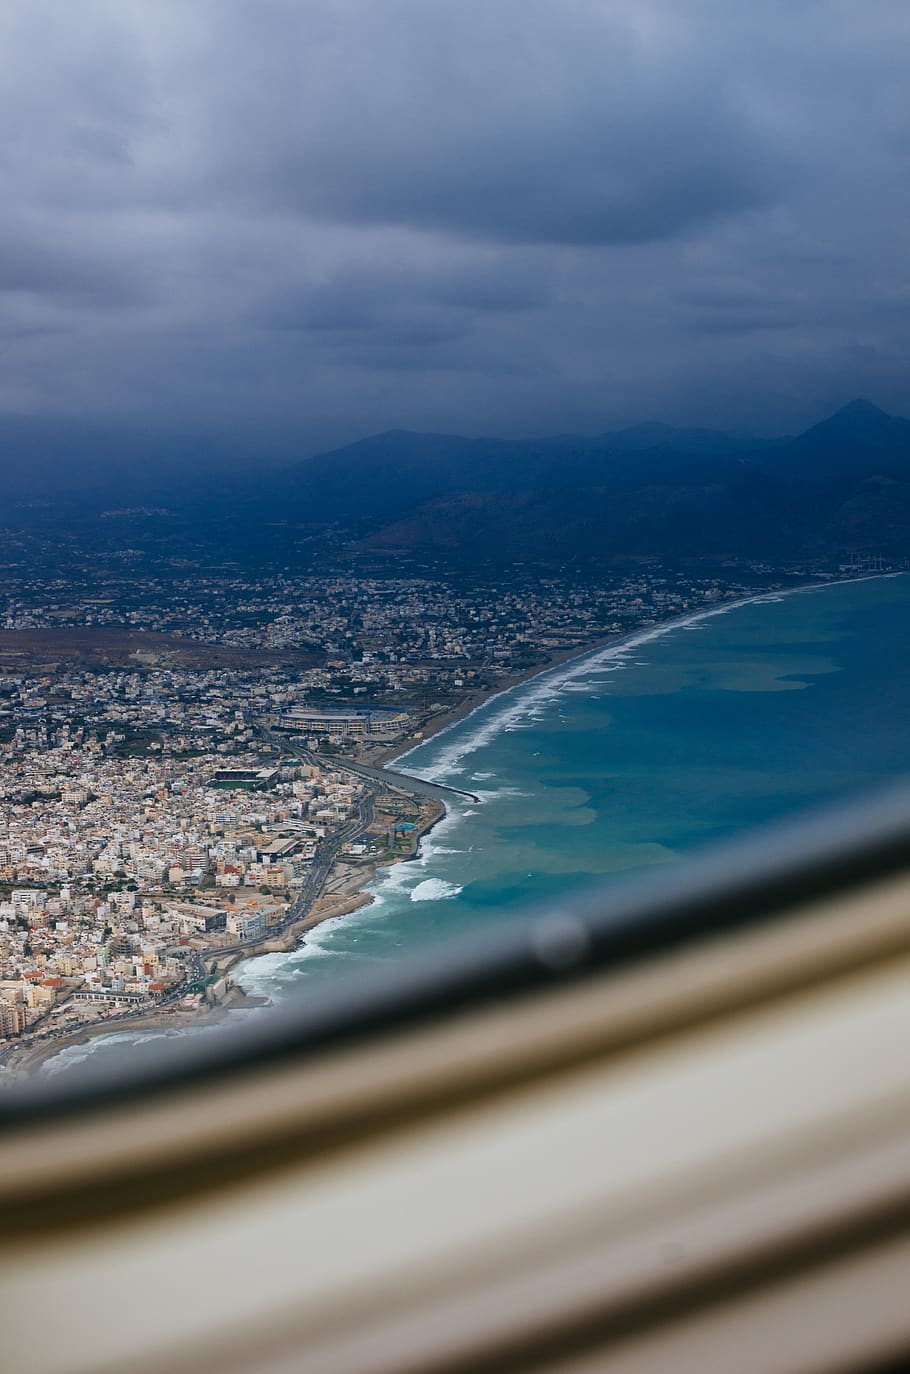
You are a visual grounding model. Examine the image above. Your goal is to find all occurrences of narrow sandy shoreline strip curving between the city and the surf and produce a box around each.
[7,572,900,1079]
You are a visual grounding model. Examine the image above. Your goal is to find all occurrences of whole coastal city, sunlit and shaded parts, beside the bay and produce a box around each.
[0,567,830,1080]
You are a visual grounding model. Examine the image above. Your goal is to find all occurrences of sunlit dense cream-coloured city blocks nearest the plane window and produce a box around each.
[0,746,371,1036]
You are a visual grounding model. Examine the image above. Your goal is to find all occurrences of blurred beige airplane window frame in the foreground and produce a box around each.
[0,808,910,1374]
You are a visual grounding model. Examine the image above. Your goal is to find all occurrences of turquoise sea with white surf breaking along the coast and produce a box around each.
[48,576,910,1072]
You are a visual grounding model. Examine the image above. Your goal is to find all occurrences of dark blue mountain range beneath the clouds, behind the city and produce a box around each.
[0,400,910,566]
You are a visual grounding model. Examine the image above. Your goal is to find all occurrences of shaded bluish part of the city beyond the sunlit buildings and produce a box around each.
[0,570,764,758]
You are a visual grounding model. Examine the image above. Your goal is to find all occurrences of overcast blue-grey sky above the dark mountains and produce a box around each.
[0,0,910,453]
